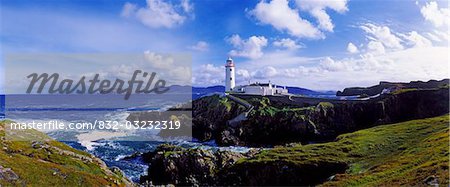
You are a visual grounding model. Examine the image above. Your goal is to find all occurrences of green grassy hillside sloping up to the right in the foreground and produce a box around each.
[232,115,449,186]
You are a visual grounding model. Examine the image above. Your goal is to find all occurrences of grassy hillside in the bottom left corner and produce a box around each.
[0,121,131,186]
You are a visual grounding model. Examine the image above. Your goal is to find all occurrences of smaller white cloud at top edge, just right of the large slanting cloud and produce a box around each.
[295,0,348,32]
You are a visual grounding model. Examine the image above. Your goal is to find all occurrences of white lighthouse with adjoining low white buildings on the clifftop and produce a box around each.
[225,58,288,96]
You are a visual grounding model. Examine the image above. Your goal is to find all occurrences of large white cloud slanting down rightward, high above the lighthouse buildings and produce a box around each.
[249,0,324,39]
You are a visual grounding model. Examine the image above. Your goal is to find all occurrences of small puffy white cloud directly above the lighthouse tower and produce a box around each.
[227,34,267,59]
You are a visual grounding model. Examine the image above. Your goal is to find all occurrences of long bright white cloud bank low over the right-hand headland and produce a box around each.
[260,47,448,90]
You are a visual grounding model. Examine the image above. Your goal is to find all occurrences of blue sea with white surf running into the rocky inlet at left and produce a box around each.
[2,93,197,182]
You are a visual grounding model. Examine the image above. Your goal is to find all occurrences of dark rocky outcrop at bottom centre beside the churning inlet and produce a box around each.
[141,144,258,186]
